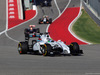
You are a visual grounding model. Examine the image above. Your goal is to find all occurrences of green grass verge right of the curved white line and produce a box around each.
[72,9,100,44]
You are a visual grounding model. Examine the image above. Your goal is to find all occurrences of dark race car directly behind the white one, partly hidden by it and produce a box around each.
[24,25,40,40]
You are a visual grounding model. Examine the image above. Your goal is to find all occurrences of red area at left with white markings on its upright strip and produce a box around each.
[7,0,36,29]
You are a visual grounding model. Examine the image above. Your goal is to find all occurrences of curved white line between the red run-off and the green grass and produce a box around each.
[68,0,91,44]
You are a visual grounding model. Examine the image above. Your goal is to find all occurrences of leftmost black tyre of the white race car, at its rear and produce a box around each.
[18,42,29,54]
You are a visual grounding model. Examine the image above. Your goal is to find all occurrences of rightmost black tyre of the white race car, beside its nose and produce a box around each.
[69,42,80,55]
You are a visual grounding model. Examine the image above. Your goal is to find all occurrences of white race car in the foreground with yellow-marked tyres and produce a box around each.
[18,33,83,56]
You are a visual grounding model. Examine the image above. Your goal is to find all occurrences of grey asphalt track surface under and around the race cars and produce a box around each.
[0,0,100,75]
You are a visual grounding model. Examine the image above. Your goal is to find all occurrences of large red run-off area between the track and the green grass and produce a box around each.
[48,7,87,45]
